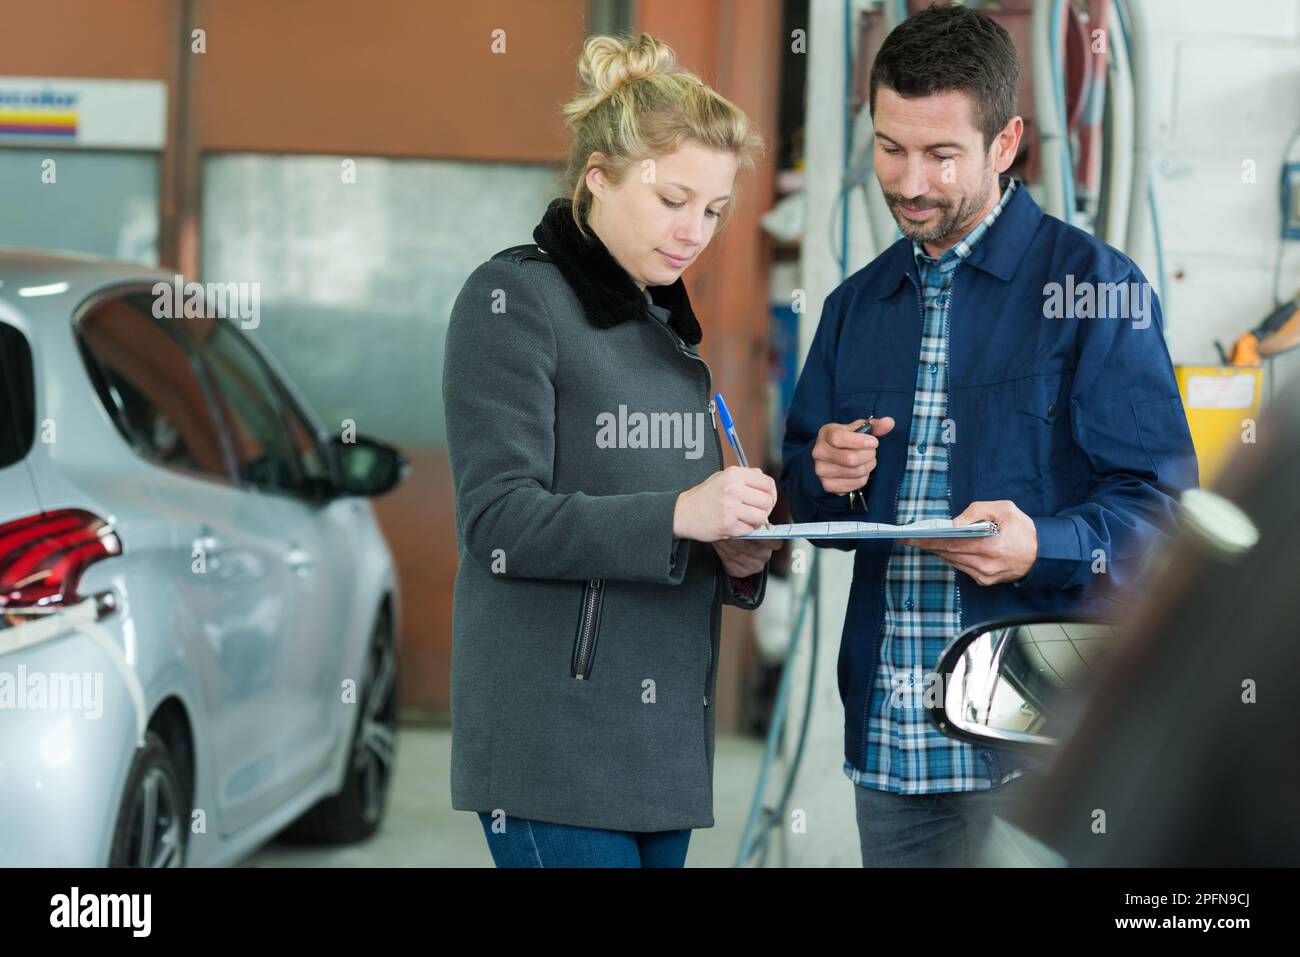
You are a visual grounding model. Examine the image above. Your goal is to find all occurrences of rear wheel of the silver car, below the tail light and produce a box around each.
[108,731,190,867]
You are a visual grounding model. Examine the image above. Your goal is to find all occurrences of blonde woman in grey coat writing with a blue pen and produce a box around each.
[443,34,776,867]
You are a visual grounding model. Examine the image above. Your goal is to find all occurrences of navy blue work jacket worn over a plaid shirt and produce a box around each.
[781,180,1197,767]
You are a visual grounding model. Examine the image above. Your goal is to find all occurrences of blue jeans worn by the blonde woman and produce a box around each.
[478,813,690,867]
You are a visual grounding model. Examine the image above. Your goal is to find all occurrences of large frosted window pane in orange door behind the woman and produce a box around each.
[202,153,555,447]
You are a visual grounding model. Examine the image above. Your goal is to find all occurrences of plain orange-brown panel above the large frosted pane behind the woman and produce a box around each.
[194,0,586,163]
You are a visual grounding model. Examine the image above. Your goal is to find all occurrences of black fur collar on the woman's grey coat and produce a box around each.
[533,199,702,346]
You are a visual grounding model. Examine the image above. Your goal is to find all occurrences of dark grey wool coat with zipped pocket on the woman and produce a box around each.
[443,237,766,831]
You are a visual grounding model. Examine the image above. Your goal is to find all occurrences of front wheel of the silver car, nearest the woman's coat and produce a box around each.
[285,610,398,844]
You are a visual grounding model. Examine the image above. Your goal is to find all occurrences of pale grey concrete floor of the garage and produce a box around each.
[244,723,763,867]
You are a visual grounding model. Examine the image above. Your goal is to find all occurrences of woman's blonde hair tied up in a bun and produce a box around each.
[564,34,763,235]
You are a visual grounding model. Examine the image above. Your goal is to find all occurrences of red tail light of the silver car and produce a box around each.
[0,508,122,620]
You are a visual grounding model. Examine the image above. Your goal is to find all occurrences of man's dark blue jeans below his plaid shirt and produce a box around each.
[853,771,1037,867]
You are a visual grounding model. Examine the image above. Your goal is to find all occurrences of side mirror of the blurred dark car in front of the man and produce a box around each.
[926,616,1117,750]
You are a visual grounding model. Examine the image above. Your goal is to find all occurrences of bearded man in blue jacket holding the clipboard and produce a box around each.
[781,5,1197,866]
